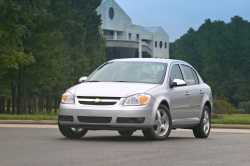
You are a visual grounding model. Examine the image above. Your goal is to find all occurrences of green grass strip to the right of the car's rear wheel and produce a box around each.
[212,114,250,125]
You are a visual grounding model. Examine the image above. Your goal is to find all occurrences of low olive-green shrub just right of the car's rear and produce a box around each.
[214,99,237,114]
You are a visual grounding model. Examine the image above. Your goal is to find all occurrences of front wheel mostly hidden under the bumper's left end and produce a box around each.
[58,124,88,139]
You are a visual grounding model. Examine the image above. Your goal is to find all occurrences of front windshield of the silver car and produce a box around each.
[87,62,167,84]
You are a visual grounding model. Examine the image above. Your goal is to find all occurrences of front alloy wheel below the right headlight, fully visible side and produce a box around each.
[142,105,172,140]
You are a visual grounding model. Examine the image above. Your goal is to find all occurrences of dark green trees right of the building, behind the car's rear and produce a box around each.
[171,16,250,106]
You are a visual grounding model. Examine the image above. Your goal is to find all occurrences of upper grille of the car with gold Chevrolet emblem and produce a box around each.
[77,96,121,106]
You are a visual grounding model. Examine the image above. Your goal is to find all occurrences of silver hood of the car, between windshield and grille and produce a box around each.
[69,82,158,97]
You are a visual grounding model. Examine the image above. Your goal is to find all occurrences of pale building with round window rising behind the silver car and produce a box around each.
[97,0,169,59]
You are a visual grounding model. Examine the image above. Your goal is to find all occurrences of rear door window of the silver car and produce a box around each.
[181,65,199,85]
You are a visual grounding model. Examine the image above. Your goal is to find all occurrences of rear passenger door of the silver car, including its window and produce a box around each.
[181,64,202,120]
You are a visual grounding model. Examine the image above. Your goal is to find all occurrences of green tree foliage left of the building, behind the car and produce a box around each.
[0,0,105,113]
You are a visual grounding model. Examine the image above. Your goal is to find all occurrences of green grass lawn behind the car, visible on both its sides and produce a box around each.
[0,114,250,125]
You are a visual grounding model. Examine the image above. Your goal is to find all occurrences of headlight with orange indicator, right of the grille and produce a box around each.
[123,94,151,106]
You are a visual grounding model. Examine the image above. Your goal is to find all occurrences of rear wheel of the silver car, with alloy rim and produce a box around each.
[193,106,211,139]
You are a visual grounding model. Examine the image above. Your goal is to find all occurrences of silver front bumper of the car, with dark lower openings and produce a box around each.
[59,104,155,130]
